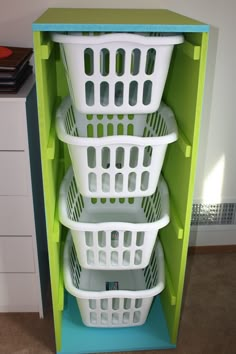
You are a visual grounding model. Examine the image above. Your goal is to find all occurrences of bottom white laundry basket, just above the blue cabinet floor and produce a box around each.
[64,234,165,327]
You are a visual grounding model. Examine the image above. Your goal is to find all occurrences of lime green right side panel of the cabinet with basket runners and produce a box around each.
[160,33,208,343]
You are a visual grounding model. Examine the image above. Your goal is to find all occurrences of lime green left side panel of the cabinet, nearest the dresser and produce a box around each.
[34,32,63,351]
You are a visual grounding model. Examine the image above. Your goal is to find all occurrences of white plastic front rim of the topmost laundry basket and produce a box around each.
[51,32,184,46]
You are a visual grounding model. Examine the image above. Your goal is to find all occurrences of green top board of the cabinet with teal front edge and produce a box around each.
[33,8,209,32]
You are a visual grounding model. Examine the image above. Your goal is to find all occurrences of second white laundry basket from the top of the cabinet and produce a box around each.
[56,97,177,198]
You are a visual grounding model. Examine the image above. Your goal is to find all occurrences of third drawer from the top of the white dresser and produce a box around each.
[0,196,34,236]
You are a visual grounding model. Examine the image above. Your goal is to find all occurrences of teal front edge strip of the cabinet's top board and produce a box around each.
[32,23,210,33]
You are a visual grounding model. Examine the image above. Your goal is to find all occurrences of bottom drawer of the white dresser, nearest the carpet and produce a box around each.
[0,273,38,312]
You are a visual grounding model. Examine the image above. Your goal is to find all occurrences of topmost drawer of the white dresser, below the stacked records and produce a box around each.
[0,100,27,150]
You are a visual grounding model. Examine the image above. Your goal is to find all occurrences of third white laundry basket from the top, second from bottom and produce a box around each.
[59,168,169,270]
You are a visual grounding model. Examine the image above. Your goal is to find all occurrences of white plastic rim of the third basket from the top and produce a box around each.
[58,167,170,232]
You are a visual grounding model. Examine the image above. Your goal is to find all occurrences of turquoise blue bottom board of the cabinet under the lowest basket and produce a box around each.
[58,292,175,354]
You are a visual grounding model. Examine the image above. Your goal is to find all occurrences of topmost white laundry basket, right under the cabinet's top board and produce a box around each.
[52,33,184,114]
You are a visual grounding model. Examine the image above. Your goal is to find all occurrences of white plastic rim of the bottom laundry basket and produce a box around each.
[63,231,165,300]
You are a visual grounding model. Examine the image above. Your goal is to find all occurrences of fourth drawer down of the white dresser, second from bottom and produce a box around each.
[0,236,35,273]
